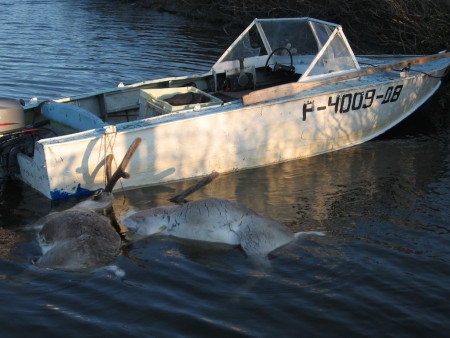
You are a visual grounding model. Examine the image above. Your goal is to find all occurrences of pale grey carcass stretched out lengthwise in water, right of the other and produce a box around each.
[121,176,323,257]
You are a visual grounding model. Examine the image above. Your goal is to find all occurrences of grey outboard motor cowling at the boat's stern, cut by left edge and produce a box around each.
[0,98,25,135]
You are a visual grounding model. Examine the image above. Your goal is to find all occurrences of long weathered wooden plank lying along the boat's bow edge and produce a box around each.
[242,53,450,106]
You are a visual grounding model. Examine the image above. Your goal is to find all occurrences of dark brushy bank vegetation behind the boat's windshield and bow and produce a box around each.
[129,0,450,54]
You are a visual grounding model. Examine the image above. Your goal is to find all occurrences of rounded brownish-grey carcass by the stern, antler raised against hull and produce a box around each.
[35,138,141,272]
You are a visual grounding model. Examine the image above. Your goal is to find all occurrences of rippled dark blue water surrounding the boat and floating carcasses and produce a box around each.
[0,0,450,337]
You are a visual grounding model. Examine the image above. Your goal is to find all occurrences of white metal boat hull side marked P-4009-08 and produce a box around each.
[18,67,445,199]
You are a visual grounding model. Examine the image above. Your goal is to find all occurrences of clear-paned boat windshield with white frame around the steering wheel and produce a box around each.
[213,18,359,81]
